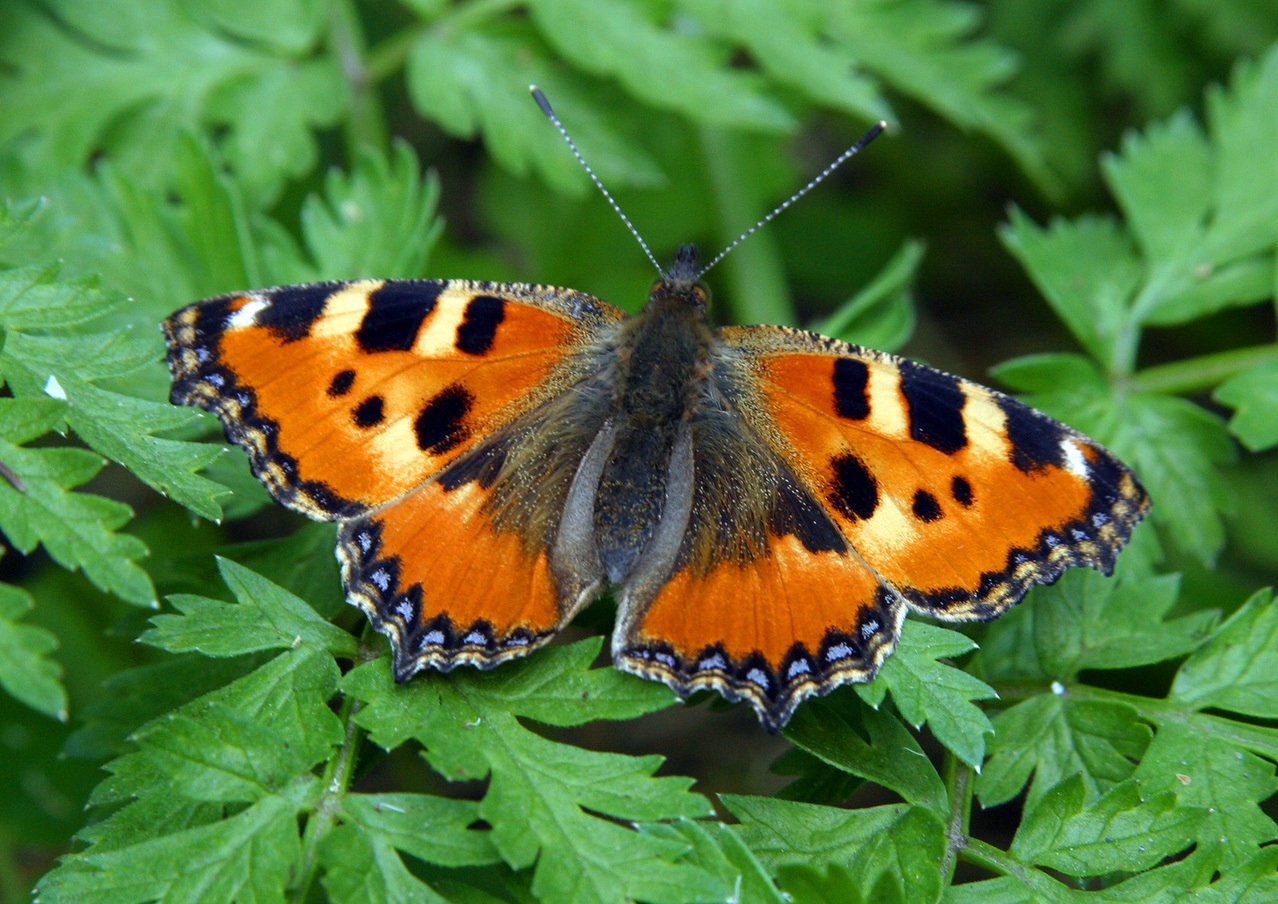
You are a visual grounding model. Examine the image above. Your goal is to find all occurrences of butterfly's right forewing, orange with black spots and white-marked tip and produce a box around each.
[725,327,1149,620]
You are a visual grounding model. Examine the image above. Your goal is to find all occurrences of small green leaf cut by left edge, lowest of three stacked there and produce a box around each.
[0,584,66,721]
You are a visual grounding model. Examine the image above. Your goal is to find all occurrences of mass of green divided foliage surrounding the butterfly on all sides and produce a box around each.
[0,0,1278,904]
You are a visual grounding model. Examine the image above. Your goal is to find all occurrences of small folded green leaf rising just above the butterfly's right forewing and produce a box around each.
[812,242,924,352]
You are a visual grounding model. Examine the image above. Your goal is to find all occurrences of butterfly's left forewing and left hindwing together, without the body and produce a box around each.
[164,280,625,679]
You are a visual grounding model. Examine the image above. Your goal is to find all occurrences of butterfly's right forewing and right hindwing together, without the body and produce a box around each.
[613,327,1149,729]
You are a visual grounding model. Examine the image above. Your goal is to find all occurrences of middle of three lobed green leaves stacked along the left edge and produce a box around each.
[0,399,155,606]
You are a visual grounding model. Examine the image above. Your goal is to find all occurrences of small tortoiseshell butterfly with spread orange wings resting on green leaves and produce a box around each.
[164,93,1149,730]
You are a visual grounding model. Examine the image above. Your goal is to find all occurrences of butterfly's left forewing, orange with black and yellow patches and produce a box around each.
[164,280,625,520]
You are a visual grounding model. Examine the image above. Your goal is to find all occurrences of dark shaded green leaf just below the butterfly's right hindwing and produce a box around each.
[785,696,948,818]
